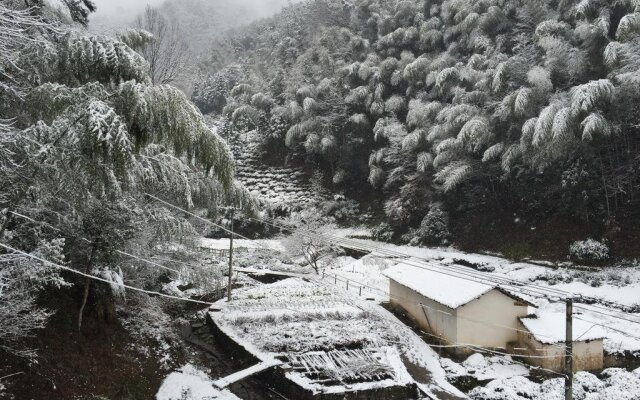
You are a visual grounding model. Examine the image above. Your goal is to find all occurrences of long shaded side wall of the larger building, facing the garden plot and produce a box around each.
[389,279,457,344]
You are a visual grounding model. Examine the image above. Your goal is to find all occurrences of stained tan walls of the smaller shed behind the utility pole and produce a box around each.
[518,322,604,373]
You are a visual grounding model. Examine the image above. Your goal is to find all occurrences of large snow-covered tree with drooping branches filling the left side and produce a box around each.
[0,1,254,354]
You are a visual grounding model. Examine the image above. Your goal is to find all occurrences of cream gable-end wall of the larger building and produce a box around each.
[458,289,528,348]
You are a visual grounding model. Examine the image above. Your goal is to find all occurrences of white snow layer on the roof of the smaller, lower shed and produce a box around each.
[520,312,605,344]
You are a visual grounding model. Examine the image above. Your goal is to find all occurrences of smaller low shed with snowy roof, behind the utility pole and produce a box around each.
[518,312,604,372]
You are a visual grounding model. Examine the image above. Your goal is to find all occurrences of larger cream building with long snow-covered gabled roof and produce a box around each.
[384,263,533,355]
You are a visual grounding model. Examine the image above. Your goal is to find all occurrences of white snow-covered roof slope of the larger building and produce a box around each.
[383,263,496,309]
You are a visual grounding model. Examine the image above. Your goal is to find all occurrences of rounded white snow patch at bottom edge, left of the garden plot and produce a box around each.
[156,364,240,400]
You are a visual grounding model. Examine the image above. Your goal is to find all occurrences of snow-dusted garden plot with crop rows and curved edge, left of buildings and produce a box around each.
[209,278,413,393]
